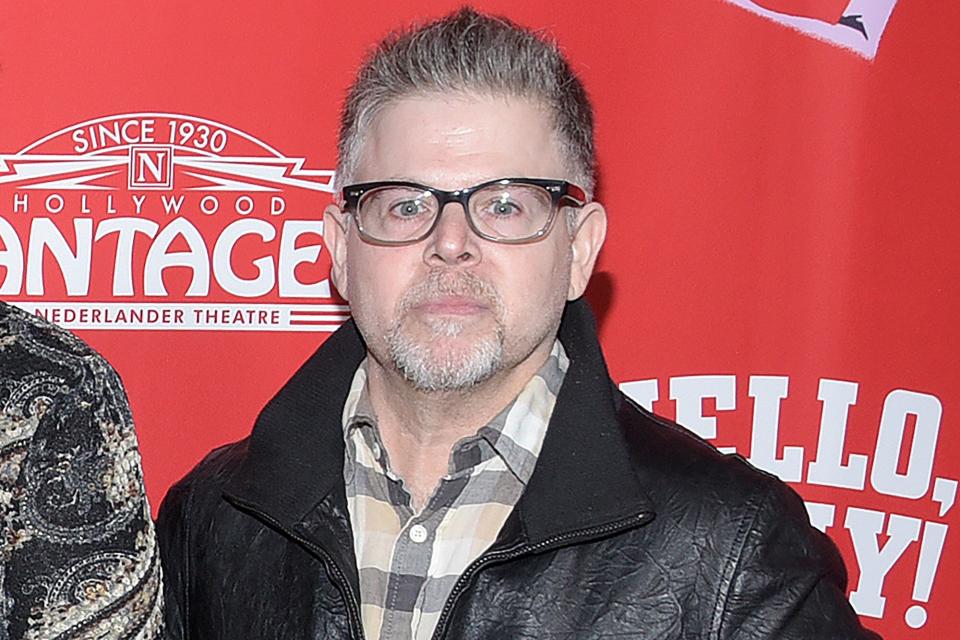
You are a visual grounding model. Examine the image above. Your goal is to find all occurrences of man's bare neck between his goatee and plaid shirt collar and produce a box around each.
[367,341,553,512]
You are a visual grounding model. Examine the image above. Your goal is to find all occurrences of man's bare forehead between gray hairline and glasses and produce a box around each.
[355,94,569,189]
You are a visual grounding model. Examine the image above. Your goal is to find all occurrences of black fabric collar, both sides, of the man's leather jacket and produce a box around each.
[226,299,651,544]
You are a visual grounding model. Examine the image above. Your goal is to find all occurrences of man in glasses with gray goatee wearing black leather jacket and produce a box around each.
[159,9,869,639]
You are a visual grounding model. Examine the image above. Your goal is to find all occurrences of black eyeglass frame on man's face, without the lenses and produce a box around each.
[340,178,587,246]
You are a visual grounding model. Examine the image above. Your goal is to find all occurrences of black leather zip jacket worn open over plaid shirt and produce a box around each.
[158,302,876,640]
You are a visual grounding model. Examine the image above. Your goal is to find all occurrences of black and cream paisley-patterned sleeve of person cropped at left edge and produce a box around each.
[0,303,162,640]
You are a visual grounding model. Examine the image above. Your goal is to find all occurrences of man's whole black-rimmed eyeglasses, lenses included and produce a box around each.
[340,178,586,245]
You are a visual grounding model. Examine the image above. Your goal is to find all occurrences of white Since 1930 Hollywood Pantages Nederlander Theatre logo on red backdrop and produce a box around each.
[0,113,348,331]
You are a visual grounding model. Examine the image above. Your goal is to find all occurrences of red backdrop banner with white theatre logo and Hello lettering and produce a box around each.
[0,0,960,639]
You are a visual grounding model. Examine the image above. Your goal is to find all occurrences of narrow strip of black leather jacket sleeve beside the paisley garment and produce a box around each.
[156,481,191,640]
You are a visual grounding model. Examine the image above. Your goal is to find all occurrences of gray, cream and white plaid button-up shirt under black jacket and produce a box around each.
[343,340,569,640]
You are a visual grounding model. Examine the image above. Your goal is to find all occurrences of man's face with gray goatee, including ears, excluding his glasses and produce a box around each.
[327,95,602,391]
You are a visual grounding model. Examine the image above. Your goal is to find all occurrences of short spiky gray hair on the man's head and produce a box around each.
[336,7,596,197]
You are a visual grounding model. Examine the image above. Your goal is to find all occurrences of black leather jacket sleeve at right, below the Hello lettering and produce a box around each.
[711,481,880,640]
